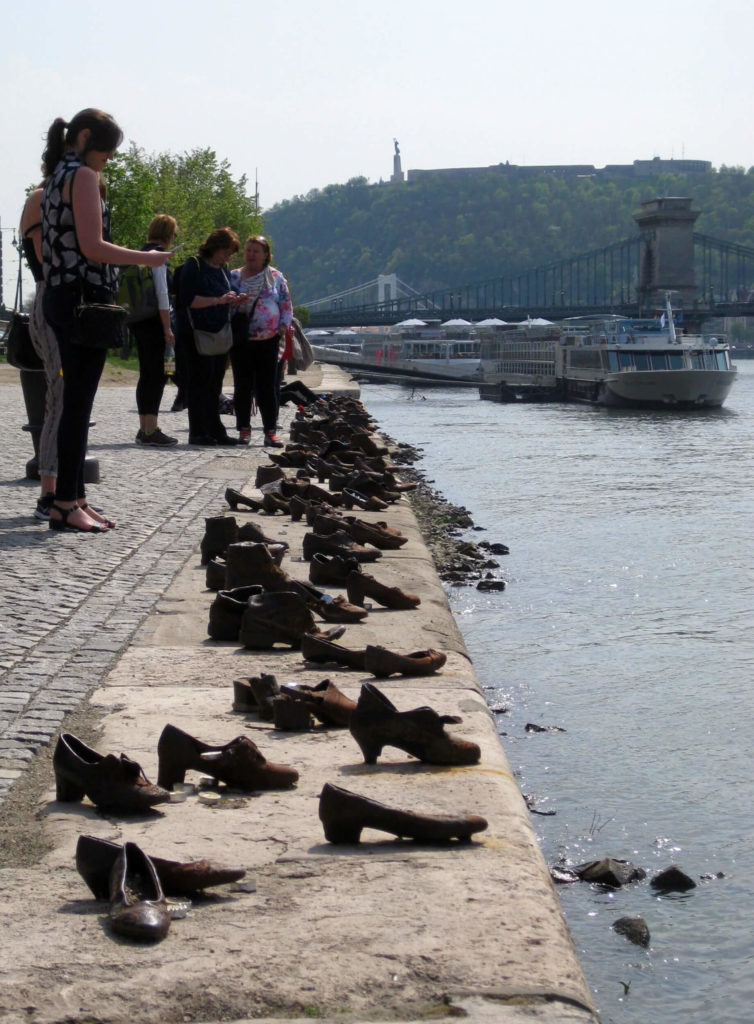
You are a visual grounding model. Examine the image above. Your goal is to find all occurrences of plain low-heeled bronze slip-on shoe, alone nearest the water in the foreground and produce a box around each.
[320,782,488,843]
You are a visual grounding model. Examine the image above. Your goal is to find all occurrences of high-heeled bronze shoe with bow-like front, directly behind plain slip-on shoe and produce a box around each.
[348,683,481,765]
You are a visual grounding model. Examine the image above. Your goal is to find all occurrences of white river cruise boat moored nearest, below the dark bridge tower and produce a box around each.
[480,296,737,409]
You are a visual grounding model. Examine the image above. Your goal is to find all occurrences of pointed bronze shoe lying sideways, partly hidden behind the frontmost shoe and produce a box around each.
[76,836,246,899]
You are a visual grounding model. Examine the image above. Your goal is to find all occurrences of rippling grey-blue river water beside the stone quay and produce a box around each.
[362,361,754,1024]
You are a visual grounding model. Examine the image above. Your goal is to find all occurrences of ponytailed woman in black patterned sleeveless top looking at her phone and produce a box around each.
[42,108,171,534]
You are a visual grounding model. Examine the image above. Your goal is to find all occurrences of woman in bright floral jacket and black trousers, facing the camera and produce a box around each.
[231,234,293,447]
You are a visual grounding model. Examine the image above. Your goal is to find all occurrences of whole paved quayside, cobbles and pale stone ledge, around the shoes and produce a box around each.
[0,367,596,1024]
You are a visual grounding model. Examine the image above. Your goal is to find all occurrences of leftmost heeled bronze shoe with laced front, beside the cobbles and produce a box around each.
[52,732,170,813]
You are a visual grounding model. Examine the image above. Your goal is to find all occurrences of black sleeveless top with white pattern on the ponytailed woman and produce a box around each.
[42,153,118,292]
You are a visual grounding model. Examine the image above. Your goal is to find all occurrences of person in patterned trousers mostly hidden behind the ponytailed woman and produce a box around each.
[19,173,62,522]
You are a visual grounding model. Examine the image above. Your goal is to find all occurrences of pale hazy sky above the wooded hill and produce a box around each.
[0,0,754,304]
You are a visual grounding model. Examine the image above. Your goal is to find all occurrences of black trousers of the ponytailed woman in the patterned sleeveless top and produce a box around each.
[43,286,108,502]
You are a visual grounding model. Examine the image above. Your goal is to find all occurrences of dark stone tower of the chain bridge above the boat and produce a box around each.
[633,197,700,312]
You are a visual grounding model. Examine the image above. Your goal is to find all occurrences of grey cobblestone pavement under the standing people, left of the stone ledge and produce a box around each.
[0,384,292,803]
